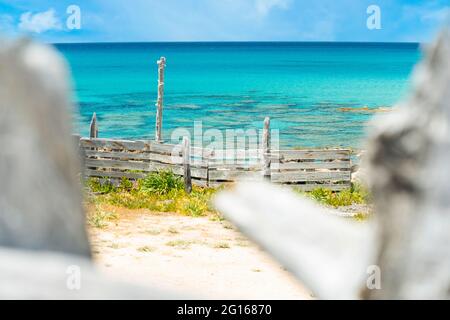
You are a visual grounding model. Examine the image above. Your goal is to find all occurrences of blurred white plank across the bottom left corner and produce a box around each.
[0,247,179,300]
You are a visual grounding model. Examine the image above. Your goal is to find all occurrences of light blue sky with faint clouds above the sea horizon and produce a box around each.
[0,0,450,42]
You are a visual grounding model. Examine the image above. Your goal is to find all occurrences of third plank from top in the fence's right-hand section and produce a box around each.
[272,171,351,182]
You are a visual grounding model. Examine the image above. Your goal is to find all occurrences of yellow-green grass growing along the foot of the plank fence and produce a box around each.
[86,171,371,216]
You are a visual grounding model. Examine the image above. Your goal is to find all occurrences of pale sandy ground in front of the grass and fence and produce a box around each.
[90,208,312,299]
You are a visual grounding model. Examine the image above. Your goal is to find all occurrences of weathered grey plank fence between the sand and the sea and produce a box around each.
[76,138,351,191]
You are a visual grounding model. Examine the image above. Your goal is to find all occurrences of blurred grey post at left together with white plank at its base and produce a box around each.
[0,40,177,299]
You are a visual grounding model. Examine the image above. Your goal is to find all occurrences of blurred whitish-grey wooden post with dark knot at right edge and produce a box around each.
[365,29,450,299]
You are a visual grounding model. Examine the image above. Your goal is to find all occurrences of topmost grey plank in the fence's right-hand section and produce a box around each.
[271,149,350,162]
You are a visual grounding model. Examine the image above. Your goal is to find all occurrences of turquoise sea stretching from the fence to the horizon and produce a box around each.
[56,42,421,147]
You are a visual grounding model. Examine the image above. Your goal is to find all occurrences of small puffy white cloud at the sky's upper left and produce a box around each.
[19,9,62,33]
